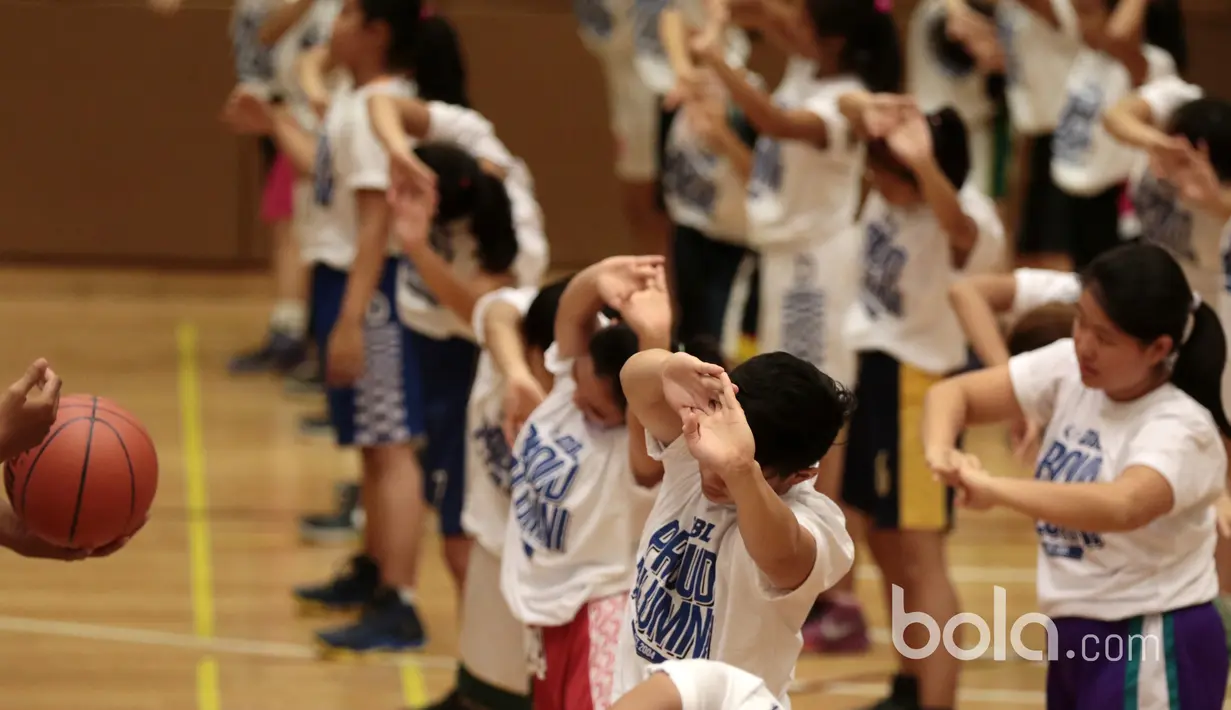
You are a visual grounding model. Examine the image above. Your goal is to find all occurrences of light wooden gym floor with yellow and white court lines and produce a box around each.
[0,268,1221,710]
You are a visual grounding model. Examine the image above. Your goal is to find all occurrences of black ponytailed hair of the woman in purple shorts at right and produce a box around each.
[1081,244,1231,438]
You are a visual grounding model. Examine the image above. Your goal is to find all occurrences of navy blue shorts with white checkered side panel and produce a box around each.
[311,258,425,447]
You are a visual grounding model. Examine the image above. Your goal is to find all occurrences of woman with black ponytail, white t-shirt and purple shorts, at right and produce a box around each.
[923,245,1231,710]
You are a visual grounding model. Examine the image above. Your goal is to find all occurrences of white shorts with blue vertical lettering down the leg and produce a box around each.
[757,229,859,390]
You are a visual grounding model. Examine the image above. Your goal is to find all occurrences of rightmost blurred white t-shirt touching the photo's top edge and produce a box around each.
[996,0,1081,135]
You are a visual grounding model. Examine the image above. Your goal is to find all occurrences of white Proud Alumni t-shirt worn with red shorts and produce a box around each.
[500,346,655,626]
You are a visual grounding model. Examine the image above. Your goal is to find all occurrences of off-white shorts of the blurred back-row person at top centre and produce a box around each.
[590,41,660,182]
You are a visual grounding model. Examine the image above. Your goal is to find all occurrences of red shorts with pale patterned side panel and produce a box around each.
[533,592,628,710]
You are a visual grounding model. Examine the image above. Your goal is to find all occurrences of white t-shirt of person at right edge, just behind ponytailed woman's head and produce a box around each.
[1131,76,1226,304]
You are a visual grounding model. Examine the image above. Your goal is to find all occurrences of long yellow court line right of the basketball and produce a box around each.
[175,324,222,710]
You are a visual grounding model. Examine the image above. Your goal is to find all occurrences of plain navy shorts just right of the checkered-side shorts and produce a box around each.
[411,332,479,538]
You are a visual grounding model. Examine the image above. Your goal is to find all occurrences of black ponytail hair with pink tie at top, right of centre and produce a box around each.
[808,0,902,94]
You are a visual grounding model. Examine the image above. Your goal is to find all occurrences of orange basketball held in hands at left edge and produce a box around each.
[5,395,158,549]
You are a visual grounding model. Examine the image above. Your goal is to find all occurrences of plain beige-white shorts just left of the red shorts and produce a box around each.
[458,545,531,695]
